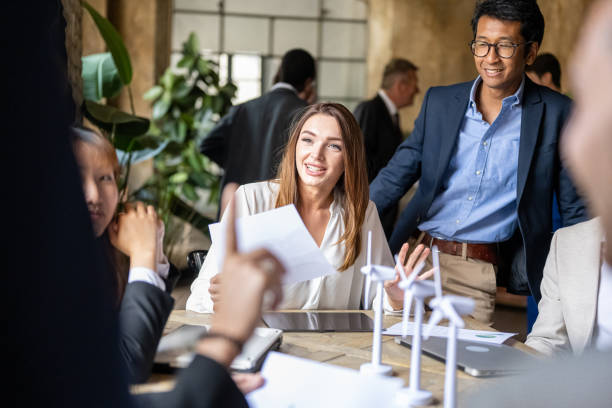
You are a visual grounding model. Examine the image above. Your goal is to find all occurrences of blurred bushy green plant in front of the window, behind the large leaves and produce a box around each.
[135,33,236,253]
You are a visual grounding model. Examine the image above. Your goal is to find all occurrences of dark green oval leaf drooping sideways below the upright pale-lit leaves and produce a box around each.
[83,101,149,137]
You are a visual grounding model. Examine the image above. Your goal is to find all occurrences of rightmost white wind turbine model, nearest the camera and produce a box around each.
[423,246,474,408]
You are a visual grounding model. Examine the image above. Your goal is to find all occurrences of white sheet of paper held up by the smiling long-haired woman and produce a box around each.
[209,204,336,284]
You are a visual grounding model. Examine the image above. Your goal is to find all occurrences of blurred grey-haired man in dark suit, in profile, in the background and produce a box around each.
[354,58,419,239]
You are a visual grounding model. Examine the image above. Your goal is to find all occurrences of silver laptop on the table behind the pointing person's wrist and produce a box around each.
[154,324,283,372]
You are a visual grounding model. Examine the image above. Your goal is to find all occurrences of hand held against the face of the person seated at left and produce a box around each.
[108,202,158,271]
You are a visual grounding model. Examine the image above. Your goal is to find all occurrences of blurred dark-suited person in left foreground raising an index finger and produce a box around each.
[23,2,283,407]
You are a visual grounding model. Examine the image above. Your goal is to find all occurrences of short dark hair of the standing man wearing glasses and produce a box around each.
[472,0,544,45]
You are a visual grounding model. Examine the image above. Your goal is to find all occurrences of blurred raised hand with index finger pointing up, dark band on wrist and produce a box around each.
[197,201,285,366]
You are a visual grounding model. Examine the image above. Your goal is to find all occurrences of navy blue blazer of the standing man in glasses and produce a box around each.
[370,78,587,301]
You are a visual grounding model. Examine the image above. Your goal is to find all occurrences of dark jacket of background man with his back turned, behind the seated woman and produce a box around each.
[200,88,307,193]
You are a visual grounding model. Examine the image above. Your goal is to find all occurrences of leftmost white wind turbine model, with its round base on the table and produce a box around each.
[360,231,395,375]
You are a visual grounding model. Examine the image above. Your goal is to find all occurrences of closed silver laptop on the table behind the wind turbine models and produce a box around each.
[395,336,538,377]
